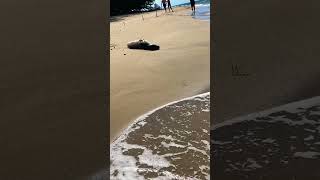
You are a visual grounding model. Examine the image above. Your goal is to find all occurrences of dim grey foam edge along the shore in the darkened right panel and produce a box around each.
[211,96,320,130]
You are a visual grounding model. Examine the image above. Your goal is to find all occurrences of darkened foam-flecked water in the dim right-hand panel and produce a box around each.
[211,97,320,180]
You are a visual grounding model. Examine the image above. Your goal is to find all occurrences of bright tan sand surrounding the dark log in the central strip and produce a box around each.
[110,8,210,140]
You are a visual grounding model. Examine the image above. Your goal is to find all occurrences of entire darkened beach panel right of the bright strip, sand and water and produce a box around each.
[211,0,320,180]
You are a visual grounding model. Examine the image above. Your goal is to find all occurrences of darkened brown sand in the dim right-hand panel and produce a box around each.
[211,0,320,124]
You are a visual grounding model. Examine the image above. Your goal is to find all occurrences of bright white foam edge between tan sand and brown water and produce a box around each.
[110,92,210,145]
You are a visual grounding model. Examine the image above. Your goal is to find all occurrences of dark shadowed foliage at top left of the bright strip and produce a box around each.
[110,0,154,16]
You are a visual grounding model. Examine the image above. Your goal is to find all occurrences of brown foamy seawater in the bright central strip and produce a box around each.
[109,93,210,180]
